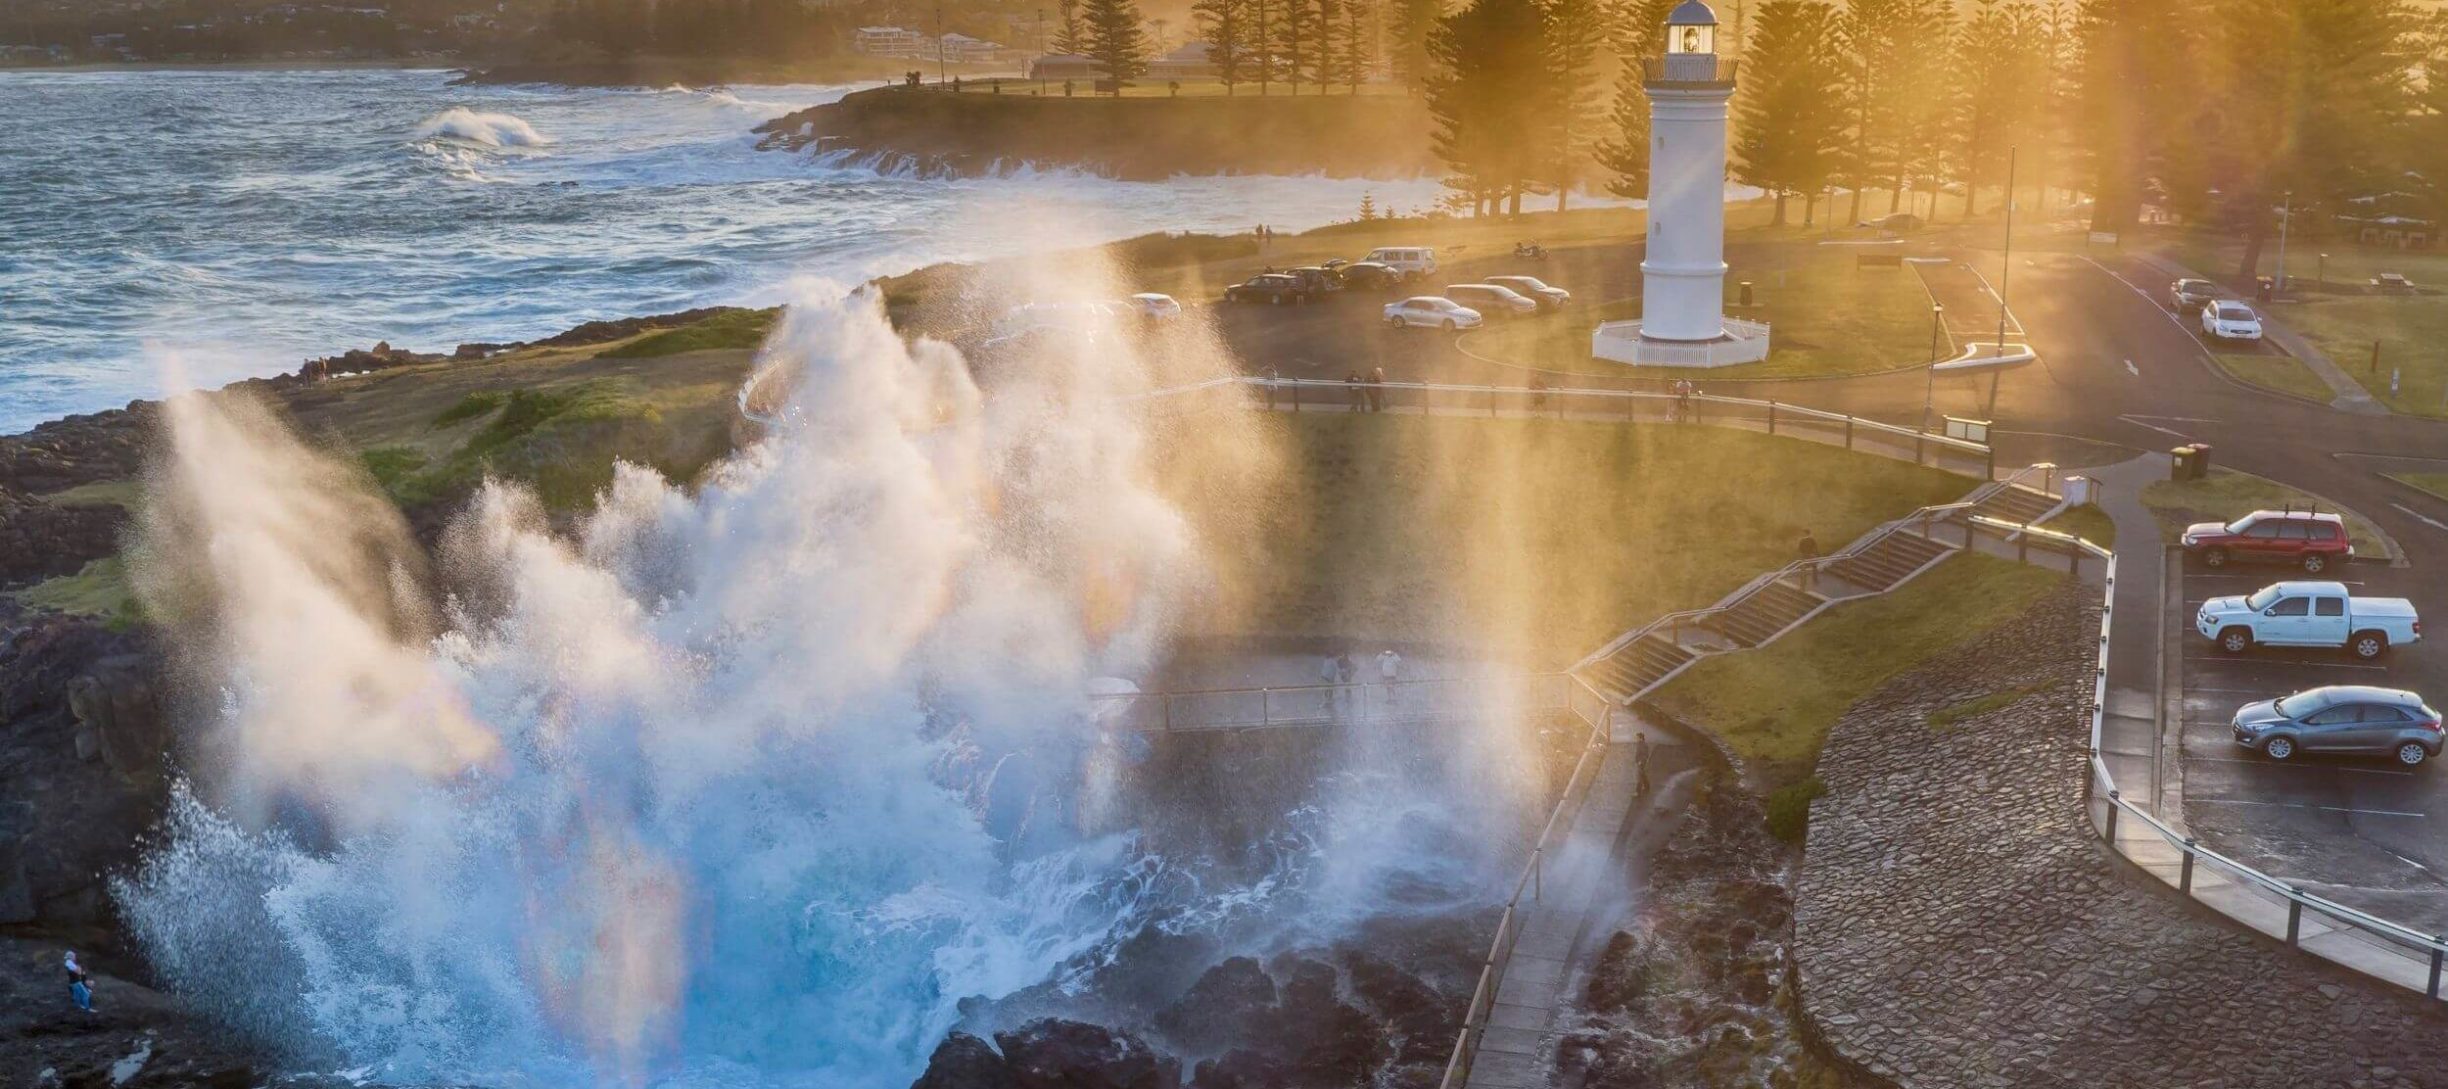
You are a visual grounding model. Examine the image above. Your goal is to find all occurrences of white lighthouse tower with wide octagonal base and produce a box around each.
[1591,0,1767,367]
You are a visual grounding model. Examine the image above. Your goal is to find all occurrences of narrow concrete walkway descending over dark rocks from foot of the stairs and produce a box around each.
[1466,712,1699,1089]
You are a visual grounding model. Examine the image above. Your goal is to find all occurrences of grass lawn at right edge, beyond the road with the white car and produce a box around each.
[2171,235,2448,416]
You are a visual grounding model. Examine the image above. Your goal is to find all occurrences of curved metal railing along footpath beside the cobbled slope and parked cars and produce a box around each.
[2075,531,2448,1001]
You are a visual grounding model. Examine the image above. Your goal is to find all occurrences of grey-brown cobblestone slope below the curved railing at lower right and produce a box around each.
[1792,587,2448,1089]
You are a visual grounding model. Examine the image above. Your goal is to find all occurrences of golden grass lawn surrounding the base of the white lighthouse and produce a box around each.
[1464,247,1929,379]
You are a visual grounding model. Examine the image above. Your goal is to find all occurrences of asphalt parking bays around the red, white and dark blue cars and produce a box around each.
[2166,563,2448,932]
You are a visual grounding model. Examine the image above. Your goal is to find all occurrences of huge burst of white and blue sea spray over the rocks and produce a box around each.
[120,275,1233,1087]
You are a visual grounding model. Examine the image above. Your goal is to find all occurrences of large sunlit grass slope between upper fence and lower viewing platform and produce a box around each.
[1158,414,1973,668]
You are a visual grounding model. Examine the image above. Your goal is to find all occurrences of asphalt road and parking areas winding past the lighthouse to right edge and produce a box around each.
[1219,227,2448,930]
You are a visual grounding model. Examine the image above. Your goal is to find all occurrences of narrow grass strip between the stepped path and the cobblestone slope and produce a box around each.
[1655,556,2066,783]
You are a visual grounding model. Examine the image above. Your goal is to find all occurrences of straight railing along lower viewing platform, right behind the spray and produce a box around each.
[1089,673,1596,734]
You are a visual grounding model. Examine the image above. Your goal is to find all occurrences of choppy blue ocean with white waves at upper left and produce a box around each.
[0,69,1437,433]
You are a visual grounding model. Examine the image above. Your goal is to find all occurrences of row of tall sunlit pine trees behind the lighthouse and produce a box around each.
[1400,0,2448,262]
